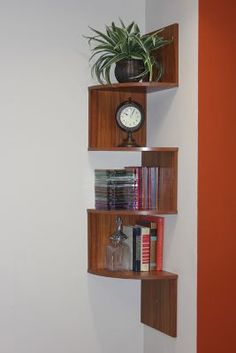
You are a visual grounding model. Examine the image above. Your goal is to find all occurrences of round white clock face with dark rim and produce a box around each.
[116,101,144,131]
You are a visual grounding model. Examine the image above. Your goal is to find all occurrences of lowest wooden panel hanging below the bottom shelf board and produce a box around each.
[141,279,177,337]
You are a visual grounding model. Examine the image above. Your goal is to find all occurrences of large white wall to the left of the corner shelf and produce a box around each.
[0,0,145,353]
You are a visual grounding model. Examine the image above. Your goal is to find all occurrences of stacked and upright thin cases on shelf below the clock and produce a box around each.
[95,166,159,210]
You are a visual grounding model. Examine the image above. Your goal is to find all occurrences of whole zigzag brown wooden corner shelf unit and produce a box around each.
[87,24,178,337]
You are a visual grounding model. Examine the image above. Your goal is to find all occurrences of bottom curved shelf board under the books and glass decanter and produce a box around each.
[88,269,178,281]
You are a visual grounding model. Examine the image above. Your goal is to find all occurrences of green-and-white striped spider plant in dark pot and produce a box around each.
[84,20,171,84]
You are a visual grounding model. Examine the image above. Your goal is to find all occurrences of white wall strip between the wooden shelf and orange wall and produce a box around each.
[144,0,198,353]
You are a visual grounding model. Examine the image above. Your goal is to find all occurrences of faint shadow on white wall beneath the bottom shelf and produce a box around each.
[87,274,143,353]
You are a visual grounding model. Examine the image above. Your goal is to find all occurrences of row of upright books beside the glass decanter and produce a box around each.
[123,216,164,271]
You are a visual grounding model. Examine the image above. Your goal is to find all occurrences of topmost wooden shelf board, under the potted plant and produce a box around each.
[89,81,178,93]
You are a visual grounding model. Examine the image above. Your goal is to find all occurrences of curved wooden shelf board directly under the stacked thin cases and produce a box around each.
[87,208,177,216]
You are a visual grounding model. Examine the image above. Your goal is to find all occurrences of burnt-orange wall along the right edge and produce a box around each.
[197,0,236,353]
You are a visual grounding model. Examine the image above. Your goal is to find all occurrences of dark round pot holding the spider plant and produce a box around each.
[115,59,144,82]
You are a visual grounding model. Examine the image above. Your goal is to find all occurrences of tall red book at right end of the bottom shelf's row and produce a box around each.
[140,216,165,271]
